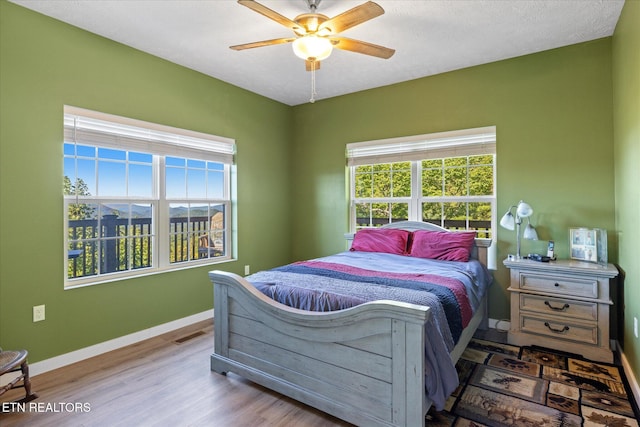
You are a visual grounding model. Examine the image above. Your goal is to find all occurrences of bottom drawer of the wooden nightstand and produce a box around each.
[520,314,599,345]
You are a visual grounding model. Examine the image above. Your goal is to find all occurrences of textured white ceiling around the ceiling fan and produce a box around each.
[10,0,624,105]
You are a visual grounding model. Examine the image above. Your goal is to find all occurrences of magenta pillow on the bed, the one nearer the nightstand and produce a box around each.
[409,230,476,262]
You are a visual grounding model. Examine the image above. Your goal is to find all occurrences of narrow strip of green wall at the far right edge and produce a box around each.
[613,0,640,384]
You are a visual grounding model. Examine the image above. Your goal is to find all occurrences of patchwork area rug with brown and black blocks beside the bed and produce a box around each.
[426,339,638,427]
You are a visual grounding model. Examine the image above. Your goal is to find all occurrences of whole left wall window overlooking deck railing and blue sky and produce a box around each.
[63,107,235,287]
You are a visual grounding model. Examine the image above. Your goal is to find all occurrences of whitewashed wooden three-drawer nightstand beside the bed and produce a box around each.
[504,259,618,363]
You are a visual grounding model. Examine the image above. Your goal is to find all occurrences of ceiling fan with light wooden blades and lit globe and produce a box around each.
[230,0,395,71]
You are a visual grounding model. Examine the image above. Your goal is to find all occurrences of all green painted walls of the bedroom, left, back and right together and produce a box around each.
[0,0,640,384]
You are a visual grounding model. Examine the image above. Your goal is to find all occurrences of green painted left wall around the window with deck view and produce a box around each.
[0,0,292,362]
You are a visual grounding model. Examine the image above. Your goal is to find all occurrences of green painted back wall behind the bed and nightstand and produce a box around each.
[293,38,617,319]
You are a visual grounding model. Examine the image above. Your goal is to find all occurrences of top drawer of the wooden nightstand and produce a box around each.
[520,273,598,298]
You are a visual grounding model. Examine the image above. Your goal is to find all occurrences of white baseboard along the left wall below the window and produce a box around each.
[29,309,213,376]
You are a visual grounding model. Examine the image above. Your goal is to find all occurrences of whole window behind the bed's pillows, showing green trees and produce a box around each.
[347,127,496,238]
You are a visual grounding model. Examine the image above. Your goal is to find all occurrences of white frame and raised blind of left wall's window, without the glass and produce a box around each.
[63,106,237,289]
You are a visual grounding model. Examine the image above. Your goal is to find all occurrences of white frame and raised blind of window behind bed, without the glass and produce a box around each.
[346,126,497,239]
